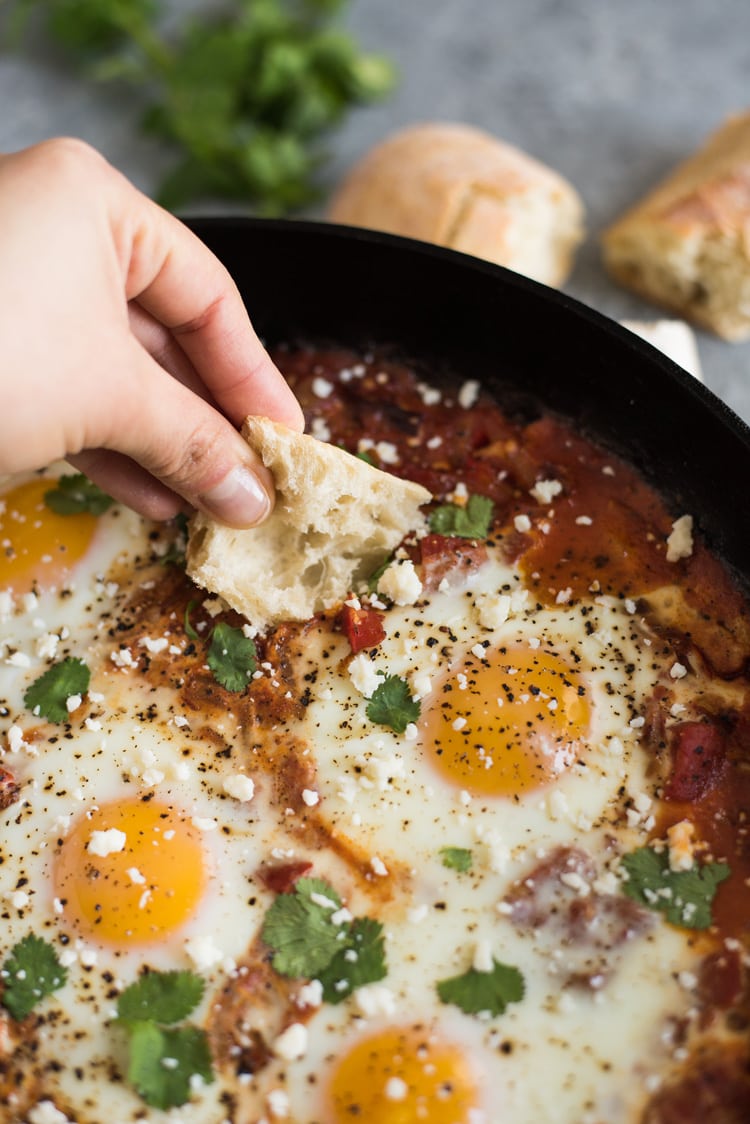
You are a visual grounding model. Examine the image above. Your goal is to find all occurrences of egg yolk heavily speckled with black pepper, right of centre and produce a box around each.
[422,647,590,796]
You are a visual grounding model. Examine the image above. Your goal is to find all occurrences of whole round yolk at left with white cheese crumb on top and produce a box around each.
[55,799,207,946]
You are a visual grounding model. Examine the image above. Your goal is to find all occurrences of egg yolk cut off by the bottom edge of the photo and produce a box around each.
[325,1027,479,1124]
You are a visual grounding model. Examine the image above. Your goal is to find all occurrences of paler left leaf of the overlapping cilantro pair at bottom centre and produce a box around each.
[261,878,347,979]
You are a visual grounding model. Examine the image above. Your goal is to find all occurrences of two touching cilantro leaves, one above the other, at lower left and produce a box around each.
[117,971,214,1108]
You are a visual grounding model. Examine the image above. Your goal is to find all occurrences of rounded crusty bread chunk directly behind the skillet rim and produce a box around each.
[328,124,584,285]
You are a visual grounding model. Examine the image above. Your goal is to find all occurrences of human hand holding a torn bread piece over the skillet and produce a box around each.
[0,139,302,526]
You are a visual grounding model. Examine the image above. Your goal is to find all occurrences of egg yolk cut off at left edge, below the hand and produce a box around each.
[0,477,97,593]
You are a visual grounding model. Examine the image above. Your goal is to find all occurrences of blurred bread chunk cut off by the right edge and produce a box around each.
[602,112,750,339]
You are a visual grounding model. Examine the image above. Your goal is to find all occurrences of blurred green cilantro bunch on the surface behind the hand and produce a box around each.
[9,0,394,215]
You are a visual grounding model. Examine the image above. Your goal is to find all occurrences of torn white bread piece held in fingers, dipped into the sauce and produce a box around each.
[188,417,432,632]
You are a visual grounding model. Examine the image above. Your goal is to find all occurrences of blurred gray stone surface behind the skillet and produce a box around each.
[0,0,750,420]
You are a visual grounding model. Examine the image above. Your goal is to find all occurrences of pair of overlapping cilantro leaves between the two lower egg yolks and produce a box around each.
[261,878,387,1004]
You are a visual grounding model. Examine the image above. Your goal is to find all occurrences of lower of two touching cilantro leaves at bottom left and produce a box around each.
[127,1022,214,1109]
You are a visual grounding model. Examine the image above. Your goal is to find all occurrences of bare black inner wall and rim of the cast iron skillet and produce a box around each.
[190,218,750,587]
